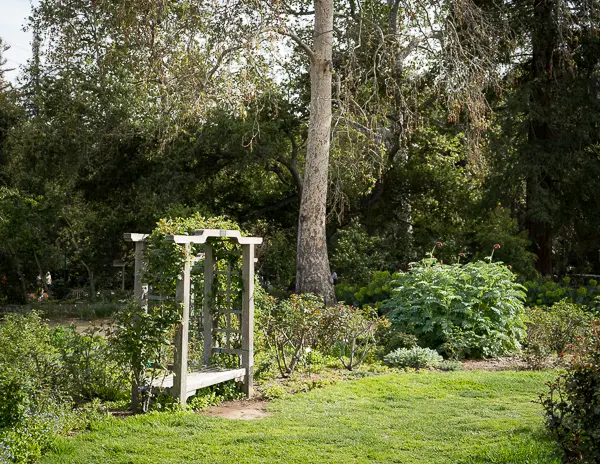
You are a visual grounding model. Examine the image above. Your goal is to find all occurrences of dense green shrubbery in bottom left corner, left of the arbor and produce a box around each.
[0,313,119,463]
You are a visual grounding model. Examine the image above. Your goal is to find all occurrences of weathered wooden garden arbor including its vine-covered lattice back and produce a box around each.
[125,229,262,405]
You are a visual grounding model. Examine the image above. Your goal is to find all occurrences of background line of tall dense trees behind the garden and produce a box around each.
[0,0,600,301]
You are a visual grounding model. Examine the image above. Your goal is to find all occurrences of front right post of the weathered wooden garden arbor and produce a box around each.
[242,244,254,398]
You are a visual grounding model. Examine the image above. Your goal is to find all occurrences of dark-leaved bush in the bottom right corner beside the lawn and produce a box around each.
[541,321,600,463]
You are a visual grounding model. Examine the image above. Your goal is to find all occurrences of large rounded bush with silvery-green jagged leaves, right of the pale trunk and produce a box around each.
[384,259,525,357]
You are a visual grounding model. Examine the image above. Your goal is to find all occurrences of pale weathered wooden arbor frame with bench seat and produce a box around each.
[125,229,262,405]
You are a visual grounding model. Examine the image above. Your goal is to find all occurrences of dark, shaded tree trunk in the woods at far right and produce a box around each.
[526,0,560,276]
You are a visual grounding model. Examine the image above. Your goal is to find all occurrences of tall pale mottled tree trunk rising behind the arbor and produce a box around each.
[296,0,335,304]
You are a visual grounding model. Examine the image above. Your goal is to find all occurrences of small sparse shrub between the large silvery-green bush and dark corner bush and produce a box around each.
[523,299,591,369]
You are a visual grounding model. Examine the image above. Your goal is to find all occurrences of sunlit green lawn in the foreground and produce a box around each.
[42,371,560,464]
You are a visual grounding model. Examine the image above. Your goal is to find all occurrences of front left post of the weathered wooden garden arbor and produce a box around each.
[173,243,191,406]
